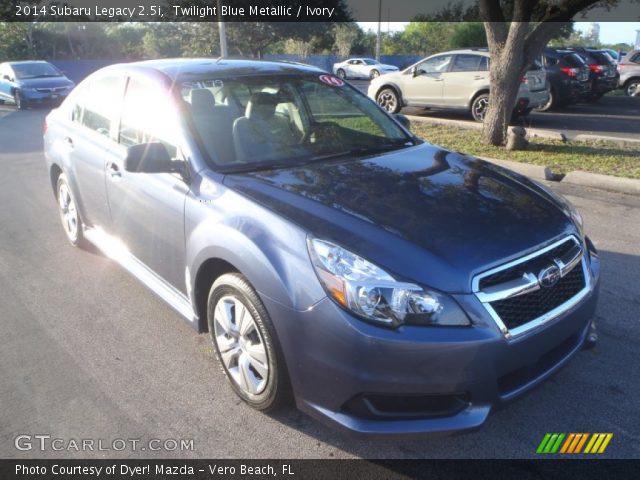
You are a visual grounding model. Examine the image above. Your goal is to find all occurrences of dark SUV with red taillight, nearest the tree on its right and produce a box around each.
[536,48,590,112]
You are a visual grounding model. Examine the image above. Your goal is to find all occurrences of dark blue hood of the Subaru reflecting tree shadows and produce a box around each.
[225,144,577,293]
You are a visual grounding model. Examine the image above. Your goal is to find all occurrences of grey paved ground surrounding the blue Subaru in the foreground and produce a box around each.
[0,107,640,458]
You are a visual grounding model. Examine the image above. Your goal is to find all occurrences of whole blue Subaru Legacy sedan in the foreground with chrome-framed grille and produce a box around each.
[45,59,600,436]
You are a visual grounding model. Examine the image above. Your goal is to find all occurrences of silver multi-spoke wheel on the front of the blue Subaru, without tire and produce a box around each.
[214,295,269,395]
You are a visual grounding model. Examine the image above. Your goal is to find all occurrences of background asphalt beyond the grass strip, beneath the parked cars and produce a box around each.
[350,80,640,140]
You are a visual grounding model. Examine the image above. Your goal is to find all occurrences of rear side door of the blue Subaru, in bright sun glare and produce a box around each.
[63,76,124,228]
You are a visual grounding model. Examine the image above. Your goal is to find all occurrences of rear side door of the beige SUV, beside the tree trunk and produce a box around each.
[442,53,489,108]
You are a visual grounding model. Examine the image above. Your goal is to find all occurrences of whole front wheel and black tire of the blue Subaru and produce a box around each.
[207,273,292,412]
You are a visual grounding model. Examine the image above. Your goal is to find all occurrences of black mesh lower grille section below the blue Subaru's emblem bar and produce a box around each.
[490,264,585,330]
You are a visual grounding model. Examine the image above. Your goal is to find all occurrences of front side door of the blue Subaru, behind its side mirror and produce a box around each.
[106,77,189,293]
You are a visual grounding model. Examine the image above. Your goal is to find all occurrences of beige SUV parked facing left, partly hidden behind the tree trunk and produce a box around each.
[368,50,549,122]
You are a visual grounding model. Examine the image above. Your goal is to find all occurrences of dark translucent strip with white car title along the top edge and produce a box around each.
[0,0,640,22]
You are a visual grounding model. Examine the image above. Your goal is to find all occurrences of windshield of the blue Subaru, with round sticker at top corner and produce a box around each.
[181,75,414,171]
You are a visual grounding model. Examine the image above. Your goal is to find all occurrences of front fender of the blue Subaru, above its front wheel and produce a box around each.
[185,172,325,316]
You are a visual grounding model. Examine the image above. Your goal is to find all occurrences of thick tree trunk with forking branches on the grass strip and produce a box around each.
[480,0,615,145]
